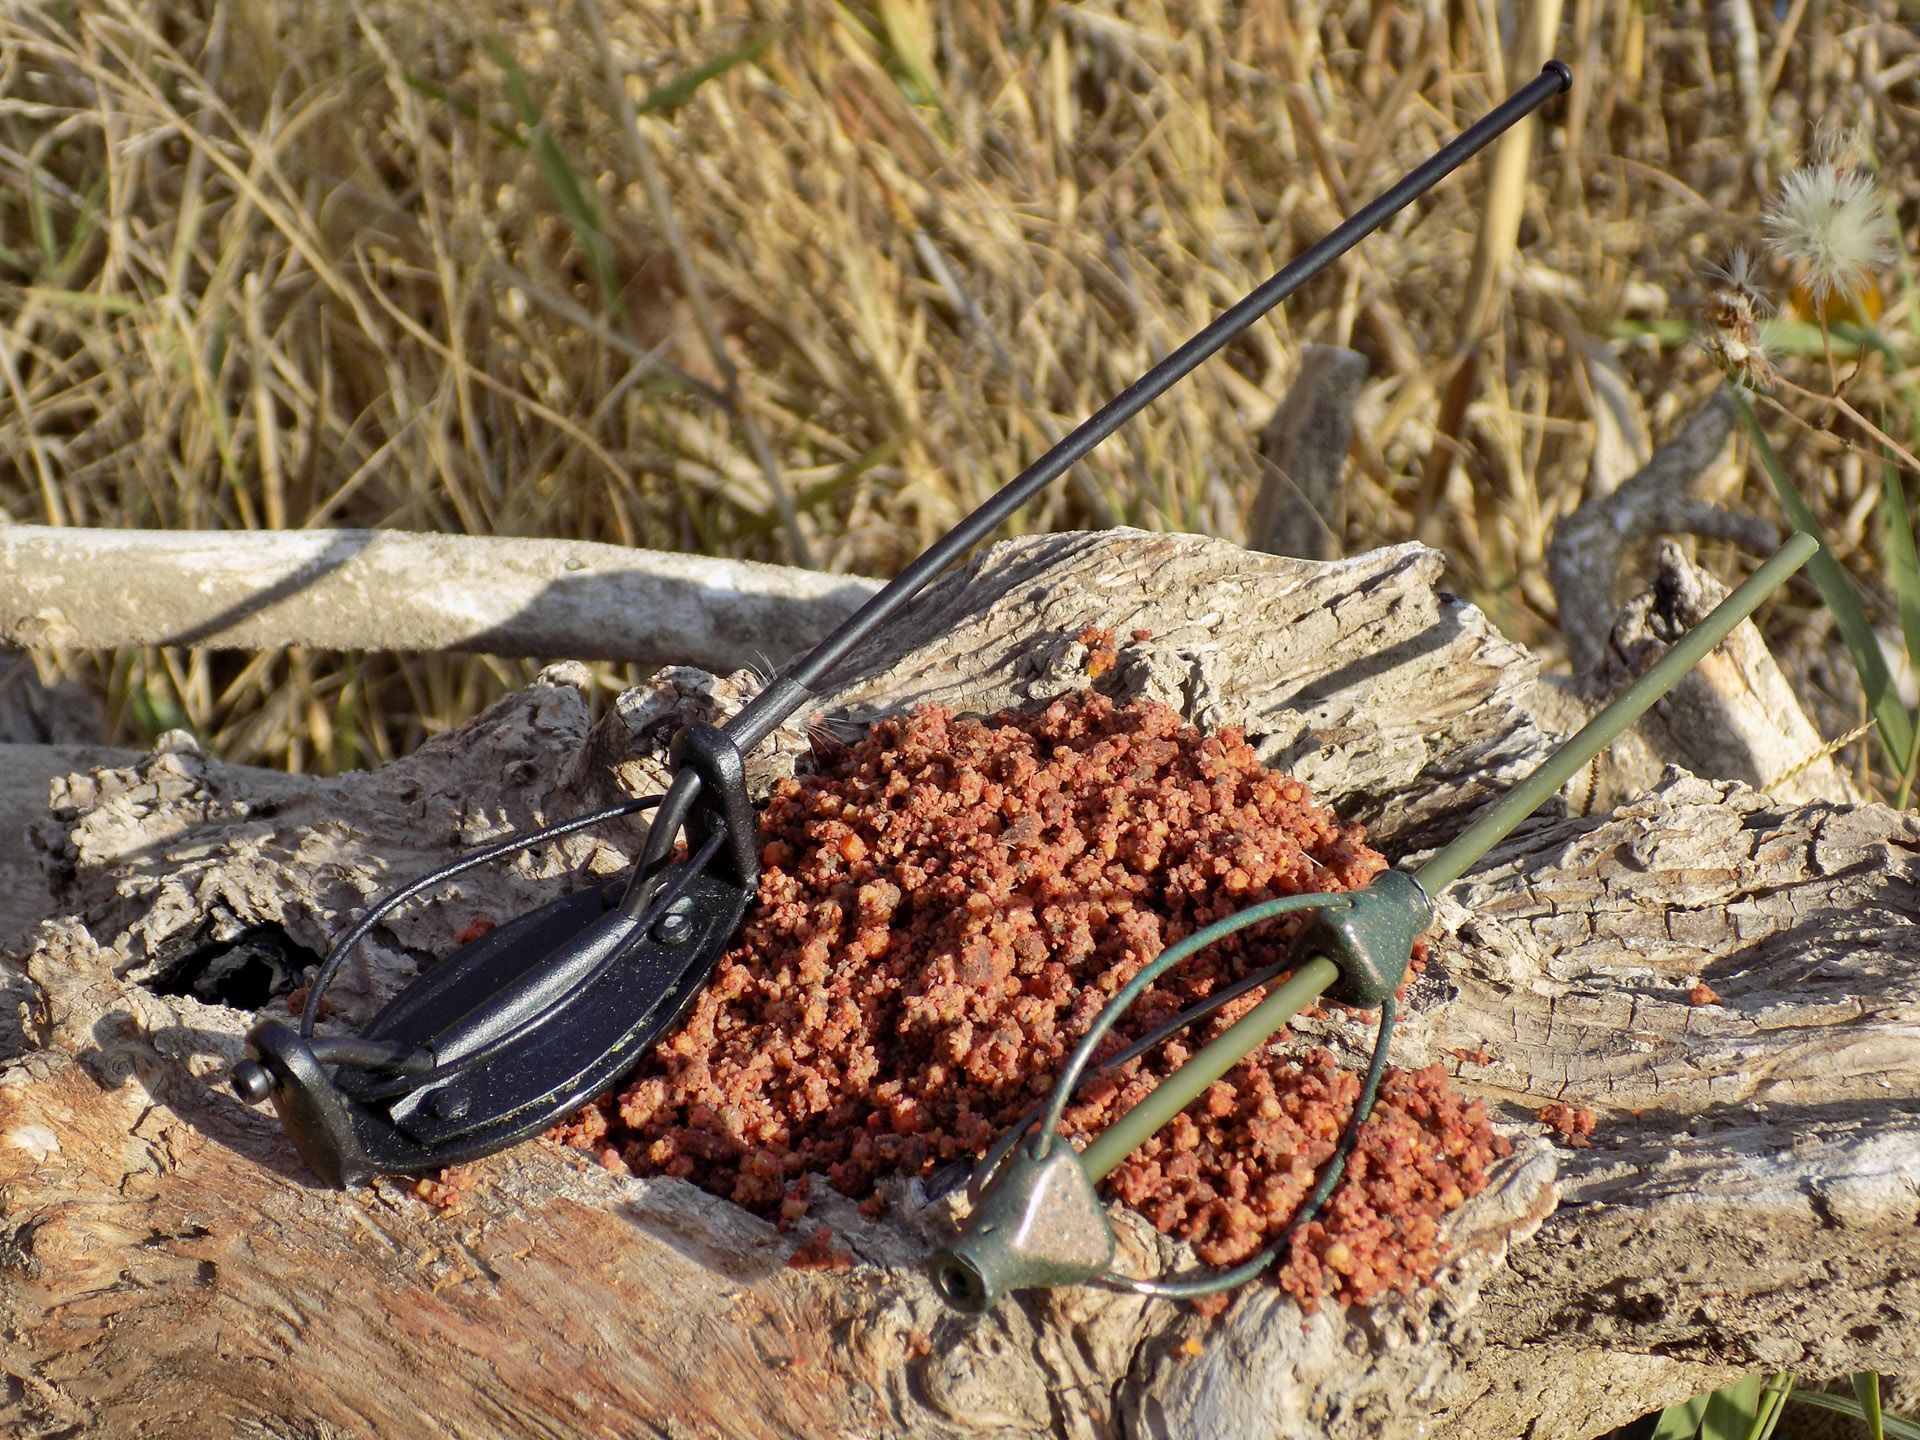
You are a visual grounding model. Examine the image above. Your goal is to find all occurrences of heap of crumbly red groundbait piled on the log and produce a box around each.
[559,693,1507,1306]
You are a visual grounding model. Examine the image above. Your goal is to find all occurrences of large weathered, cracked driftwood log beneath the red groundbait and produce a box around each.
[0,534,1920,1440]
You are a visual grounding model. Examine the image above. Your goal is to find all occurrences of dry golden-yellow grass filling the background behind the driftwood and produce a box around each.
[0,0,1920,770]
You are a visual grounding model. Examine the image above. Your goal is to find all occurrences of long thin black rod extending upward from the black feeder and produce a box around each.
[622,60,1572,914]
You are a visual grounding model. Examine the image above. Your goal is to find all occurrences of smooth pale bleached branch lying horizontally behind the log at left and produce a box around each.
[0,524,876,674]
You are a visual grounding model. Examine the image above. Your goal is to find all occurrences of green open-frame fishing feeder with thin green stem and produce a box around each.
[929,534,1820,1315]
